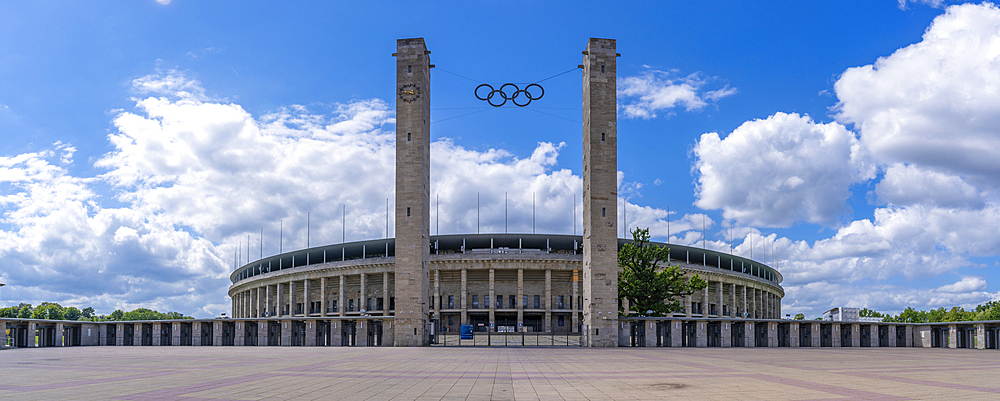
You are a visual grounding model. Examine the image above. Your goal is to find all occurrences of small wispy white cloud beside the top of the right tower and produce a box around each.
[618,70,736,119]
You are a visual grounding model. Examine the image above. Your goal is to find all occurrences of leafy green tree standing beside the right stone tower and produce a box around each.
[618,228,708,316]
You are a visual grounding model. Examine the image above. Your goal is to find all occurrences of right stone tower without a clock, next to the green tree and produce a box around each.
[583,38,618,347]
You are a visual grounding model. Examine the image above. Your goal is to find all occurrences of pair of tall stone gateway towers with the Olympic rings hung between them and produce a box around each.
[390,38,619,347]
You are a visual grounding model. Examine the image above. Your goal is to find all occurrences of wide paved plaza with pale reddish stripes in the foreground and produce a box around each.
[0,347,1000,400]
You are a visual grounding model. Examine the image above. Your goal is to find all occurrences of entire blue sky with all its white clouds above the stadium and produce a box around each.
[0,0,1000,316]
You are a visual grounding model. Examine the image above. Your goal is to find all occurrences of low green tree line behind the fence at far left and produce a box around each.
[0,302,193,322]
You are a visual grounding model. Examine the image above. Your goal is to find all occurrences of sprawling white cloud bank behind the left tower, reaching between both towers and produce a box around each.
[0,71,712,316]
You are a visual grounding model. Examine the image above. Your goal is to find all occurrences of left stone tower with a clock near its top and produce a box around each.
[393,38,431,347]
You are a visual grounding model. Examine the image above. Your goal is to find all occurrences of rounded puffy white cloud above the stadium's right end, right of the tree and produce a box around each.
[694,113,874,227]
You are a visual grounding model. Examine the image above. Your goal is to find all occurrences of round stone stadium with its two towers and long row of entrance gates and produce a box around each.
[0,38,1000,348]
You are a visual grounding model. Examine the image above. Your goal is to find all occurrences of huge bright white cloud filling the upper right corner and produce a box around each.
[834,3,1000,186]
